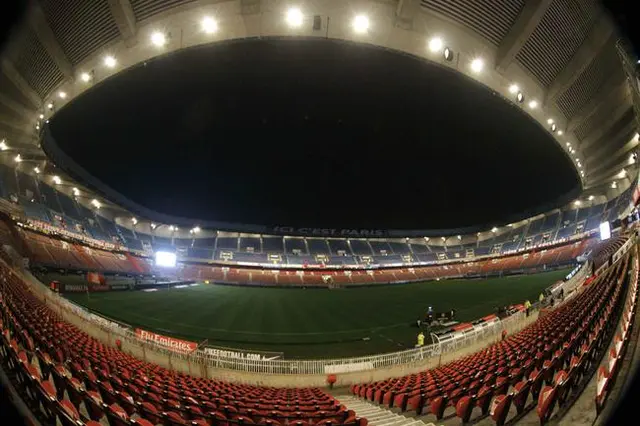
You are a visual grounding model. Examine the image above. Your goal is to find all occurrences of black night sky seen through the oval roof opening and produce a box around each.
[51,39,578,229]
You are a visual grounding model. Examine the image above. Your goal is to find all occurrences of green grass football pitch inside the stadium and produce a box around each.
[60,269,569,359]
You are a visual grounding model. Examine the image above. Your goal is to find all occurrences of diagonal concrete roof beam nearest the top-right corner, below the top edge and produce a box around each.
[545,15,619,105]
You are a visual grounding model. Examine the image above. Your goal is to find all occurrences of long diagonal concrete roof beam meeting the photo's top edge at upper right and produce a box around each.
[496,0,552,72]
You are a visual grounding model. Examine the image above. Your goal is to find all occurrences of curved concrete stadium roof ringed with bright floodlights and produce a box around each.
[0,0,639,235]
